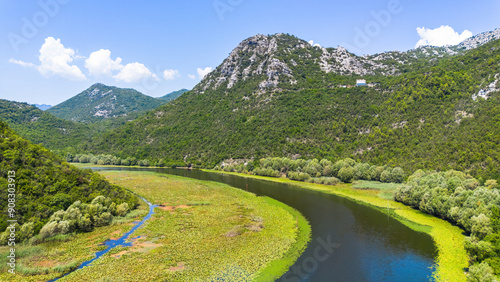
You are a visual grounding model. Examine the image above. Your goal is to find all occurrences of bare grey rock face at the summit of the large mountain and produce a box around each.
[195,34,397,93]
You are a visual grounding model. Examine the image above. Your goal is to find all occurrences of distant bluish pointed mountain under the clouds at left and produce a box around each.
[47,83,166,123]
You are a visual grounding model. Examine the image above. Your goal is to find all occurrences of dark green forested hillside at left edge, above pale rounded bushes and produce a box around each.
[0,121,138,239]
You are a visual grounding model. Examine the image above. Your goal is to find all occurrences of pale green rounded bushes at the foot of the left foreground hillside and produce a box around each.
[0,196,130,246]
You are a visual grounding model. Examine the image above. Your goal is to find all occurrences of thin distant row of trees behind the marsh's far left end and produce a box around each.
[66,153,185,167]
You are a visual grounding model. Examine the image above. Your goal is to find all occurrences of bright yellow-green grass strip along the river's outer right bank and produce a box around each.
[203,169,469,281]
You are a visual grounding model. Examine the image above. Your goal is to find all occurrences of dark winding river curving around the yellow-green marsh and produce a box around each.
[94,168,436,282]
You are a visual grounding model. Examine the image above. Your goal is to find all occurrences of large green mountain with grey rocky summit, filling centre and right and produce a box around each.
[86,34,500,179]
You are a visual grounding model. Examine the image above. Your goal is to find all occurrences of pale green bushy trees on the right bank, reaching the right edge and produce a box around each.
[395,170,500,281]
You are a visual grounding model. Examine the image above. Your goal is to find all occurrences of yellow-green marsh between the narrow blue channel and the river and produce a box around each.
[61,171,310,281]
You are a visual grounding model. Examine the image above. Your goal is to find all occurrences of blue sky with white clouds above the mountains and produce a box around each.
[0,0,500,105]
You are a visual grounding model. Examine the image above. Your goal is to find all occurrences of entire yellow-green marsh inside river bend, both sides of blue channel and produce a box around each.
[0,171,311,281]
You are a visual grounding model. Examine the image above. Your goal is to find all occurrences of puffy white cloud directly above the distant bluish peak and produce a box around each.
[85,49,123,76]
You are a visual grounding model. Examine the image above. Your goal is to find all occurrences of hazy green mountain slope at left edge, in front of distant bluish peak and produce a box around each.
[0,99,91,150]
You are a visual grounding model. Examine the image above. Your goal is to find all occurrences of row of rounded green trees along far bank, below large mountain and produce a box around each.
[215,157,405,185]
